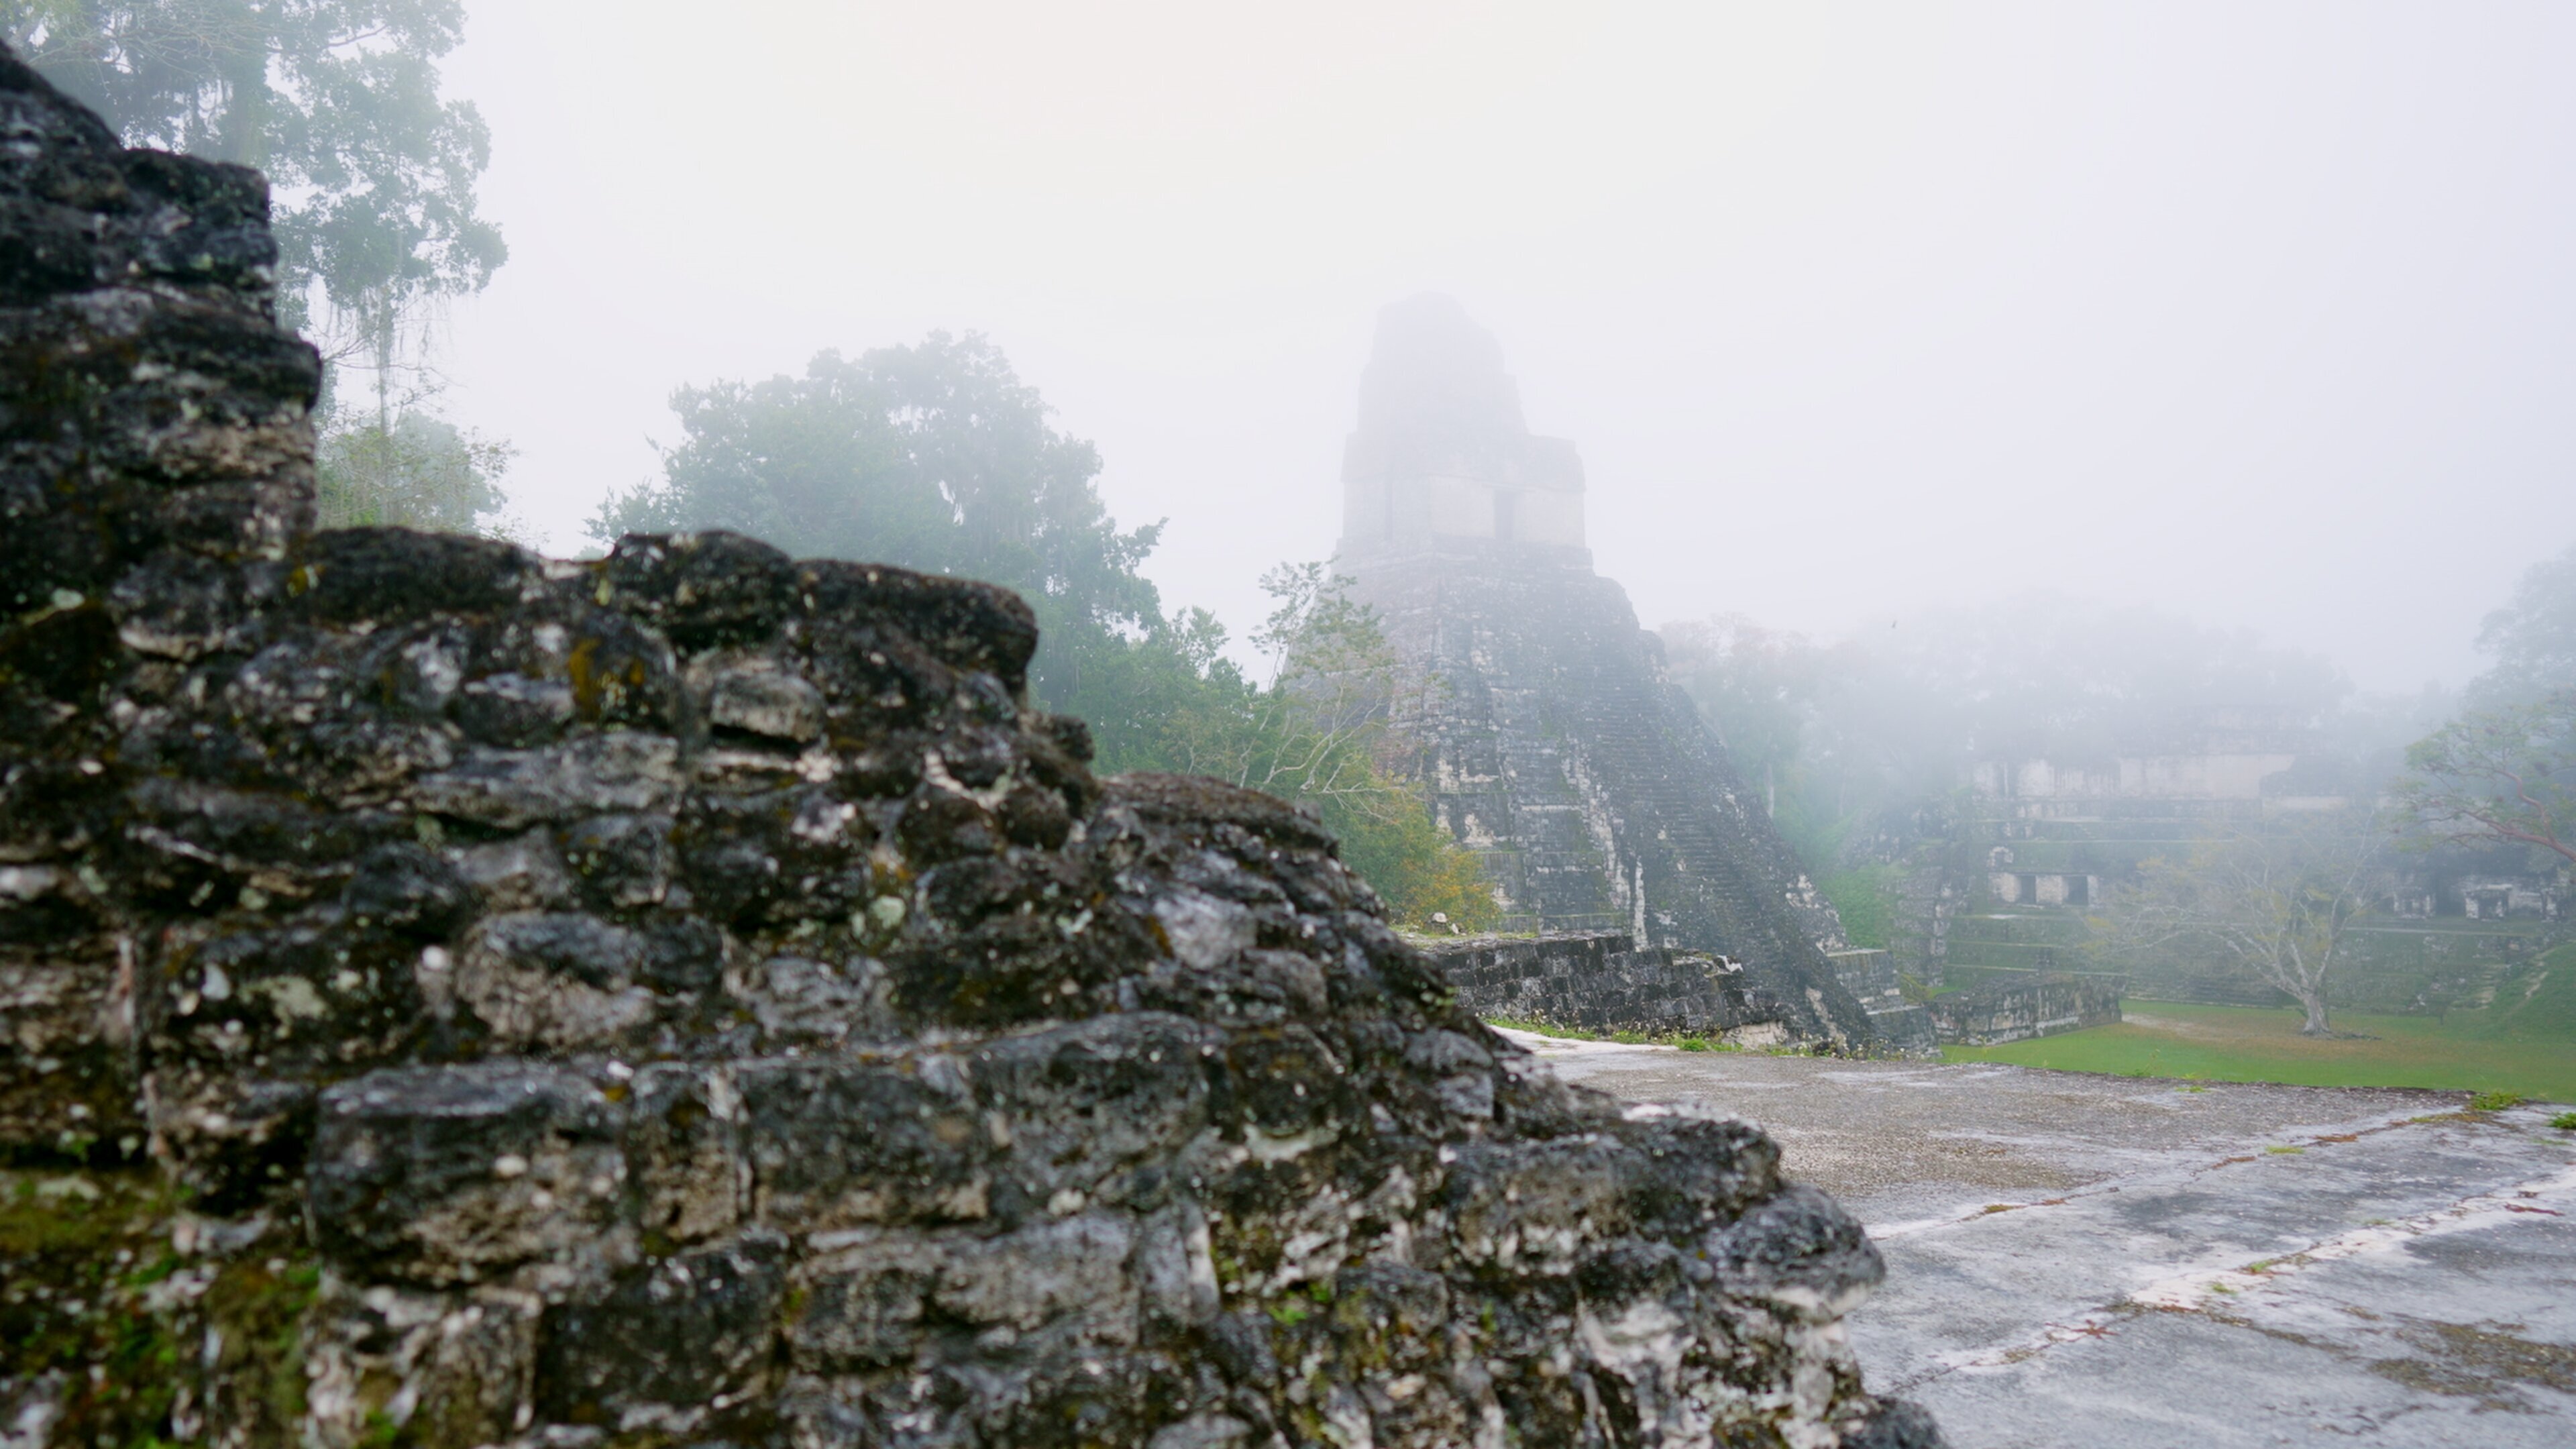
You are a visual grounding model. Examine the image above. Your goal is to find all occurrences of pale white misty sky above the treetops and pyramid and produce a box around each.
[445,0,2576,688]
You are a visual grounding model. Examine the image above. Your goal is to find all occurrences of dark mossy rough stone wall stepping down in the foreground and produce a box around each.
[0,54,1937,1449]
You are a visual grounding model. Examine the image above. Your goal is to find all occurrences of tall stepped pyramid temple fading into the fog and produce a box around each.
[1337,297,1932,1049]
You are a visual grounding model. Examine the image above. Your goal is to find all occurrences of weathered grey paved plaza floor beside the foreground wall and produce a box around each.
[1520,1036,2576,1449]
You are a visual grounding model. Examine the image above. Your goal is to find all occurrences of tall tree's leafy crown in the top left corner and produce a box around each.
[0,0,507,347]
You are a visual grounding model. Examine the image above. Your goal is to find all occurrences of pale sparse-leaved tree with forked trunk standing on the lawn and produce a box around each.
[2094,815,2385,1036]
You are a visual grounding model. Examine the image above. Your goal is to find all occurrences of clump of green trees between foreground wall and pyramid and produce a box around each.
[590,333,1499,930]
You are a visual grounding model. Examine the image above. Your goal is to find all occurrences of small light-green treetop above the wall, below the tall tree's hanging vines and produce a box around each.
[314,410,513,534]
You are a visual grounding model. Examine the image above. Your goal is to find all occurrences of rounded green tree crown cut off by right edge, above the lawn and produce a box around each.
[2398,688,2576,864]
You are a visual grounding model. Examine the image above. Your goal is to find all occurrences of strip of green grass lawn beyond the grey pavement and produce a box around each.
[1942,947,2576,1101]
